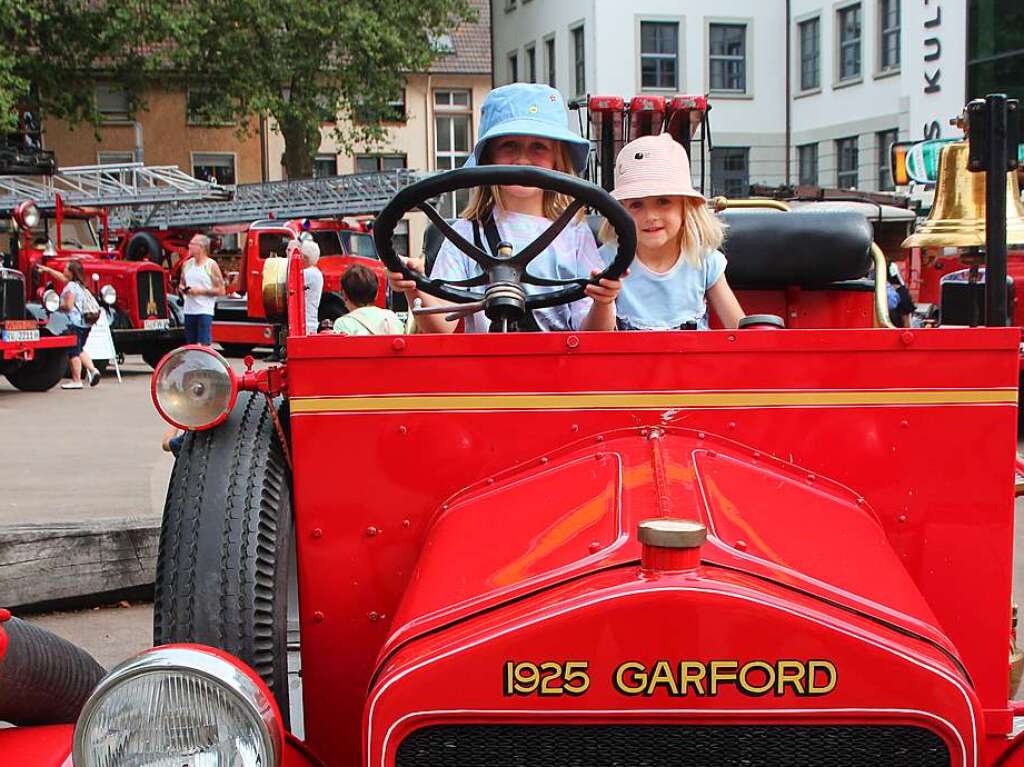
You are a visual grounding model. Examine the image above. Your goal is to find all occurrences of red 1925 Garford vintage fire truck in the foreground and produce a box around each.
[0,95,1024,767]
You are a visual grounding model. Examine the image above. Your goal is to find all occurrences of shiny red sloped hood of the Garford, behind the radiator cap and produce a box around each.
[382,428,956,656]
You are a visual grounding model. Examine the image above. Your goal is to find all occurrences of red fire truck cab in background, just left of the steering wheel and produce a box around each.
[213,218,387,354]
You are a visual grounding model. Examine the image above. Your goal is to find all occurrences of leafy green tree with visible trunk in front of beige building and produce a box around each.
[170,0,474,178]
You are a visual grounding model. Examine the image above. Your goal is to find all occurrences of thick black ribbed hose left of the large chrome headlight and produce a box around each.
[0,617,105,726]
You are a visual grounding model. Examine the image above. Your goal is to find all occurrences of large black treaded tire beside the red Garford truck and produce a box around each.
[153,391,292,722]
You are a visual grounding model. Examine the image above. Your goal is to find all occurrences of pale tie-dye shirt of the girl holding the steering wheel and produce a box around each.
[430,211,601,333]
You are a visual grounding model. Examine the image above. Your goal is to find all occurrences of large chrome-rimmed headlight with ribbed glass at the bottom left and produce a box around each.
[73,646,284,767]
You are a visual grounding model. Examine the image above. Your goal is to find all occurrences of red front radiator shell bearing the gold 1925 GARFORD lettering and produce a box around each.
[372,566,982,767]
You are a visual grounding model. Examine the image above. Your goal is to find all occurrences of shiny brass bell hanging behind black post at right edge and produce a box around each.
[902,141,1024,248]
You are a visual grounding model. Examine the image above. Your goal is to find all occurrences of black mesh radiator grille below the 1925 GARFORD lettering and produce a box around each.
[395,725,949,767]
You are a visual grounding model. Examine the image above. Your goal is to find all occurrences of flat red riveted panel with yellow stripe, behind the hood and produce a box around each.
[278,329,1019,754]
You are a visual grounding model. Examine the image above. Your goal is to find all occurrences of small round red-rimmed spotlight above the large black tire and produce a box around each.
[153,344,239,430]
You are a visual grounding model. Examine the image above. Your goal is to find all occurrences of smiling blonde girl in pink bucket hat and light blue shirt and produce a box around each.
[600,133,743,330]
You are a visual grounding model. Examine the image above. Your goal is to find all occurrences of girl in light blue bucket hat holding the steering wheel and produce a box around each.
[389,83,622,333]
